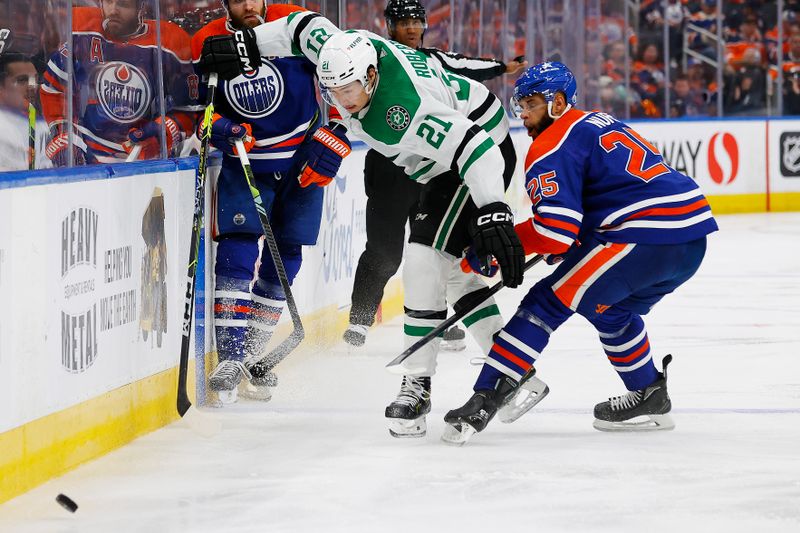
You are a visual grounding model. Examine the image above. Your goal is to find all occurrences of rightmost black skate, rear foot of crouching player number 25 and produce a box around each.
[593,355,675,431]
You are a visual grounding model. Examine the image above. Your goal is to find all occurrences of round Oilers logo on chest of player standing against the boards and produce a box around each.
[225,60,284,118]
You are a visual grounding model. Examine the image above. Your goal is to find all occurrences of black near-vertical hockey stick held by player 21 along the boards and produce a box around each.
[178,72,217,417]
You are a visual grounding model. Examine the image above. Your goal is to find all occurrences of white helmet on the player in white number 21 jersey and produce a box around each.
[317,31,378,103]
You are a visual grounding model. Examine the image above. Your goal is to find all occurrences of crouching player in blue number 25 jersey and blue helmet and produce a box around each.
[443,62,718,444]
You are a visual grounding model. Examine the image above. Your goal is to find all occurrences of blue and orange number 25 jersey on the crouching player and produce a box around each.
[525,109,718,253]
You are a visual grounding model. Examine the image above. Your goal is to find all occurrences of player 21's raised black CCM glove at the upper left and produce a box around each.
[197,28,261,80]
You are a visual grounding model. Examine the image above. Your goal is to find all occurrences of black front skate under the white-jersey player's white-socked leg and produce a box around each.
[385,376,431,438]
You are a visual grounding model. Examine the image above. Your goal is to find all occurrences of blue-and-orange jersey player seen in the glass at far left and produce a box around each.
[40,0,198,167]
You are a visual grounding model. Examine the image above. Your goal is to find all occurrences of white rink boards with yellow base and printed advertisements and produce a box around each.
[0,116,800,502]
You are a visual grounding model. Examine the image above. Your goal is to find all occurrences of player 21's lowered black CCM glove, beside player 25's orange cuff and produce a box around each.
[469,202,525,287]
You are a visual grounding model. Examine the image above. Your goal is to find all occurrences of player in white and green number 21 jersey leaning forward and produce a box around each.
[200,12,524,436]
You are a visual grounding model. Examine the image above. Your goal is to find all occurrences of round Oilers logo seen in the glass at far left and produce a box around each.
[95,61,152,123]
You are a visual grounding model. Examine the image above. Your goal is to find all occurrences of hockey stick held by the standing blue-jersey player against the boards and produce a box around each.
[236,140,306,378]
